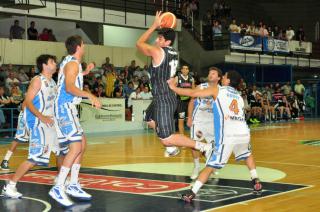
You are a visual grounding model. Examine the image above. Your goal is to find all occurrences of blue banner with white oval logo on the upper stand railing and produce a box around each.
[230,33,262,52]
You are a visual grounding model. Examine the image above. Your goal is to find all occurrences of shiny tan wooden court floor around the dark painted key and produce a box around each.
[0,119,320,212]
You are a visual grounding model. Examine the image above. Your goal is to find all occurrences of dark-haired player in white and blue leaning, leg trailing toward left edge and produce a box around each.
[2,55,58,198]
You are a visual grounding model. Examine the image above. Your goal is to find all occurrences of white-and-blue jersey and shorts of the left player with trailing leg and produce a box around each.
[24,75,58,166]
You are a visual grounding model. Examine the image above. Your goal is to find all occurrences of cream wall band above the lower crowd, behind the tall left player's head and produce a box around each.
[0,38,149,67]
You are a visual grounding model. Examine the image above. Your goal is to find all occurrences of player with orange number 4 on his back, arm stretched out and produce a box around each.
[168,71,262,202]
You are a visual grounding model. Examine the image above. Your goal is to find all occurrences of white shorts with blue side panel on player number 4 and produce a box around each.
[206,142,251,169]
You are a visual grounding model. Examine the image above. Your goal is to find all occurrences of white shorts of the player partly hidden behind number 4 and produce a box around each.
[190,121,214,143]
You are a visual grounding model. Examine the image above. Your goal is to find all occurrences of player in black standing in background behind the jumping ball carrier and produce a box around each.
[176,65,195,134]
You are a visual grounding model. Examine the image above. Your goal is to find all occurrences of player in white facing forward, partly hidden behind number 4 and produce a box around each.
[187,67,222,180]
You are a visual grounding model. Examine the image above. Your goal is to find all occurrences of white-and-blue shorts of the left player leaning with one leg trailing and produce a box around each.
[28,123,59,166]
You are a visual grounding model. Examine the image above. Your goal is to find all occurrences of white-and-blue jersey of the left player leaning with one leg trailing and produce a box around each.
[24,74,57,128]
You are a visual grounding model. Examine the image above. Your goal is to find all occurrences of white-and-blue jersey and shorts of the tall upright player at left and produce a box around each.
[54,55,83,154]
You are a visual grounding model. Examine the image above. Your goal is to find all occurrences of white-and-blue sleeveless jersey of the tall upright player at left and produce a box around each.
[55,55,83,105]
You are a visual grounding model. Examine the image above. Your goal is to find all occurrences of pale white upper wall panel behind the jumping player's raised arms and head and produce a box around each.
[103,25,178,49]
